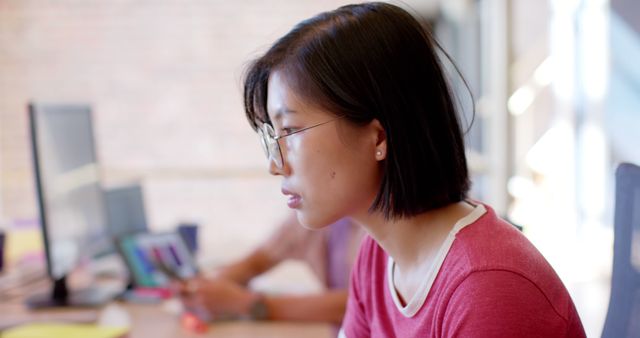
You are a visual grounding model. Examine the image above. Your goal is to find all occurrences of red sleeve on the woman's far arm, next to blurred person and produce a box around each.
[340,237,373,338]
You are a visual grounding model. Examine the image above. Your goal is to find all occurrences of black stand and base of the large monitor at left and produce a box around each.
[26,276,113,309]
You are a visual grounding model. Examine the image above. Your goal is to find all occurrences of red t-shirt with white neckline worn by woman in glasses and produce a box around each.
[341,205,585,338]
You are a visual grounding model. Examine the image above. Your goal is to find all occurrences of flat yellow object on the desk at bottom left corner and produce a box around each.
[0,323,129,338]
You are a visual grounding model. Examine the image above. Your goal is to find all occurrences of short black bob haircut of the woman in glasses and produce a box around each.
[244,2,469,219]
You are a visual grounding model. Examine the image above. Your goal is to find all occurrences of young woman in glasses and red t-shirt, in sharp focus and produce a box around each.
[244,3,585,338]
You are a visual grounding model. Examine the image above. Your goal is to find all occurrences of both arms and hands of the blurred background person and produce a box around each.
[184,213,347,323]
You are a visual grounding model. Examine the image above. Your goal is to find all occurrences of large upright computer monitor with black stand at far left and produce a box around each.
[27,103,112,307]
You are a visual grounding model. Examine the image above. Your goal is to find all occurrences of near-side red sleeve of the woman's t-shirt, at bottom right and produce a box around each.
[442,270,584,338]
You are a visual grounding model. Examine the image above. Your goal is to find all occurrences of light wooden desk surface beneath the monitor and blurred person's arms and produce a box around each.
[0,278,336,338]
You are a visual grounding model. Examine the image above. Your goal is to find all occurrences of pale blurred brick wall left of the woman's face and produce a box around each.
[0,0,360,257]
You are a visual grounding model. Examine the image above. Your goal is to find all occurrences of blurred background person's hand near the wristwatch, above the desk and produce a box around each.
[178,277,258,320]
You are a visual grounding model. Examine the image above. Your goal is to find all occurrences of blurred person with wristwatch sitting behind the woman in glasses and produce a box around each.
[179,213,363,324]
